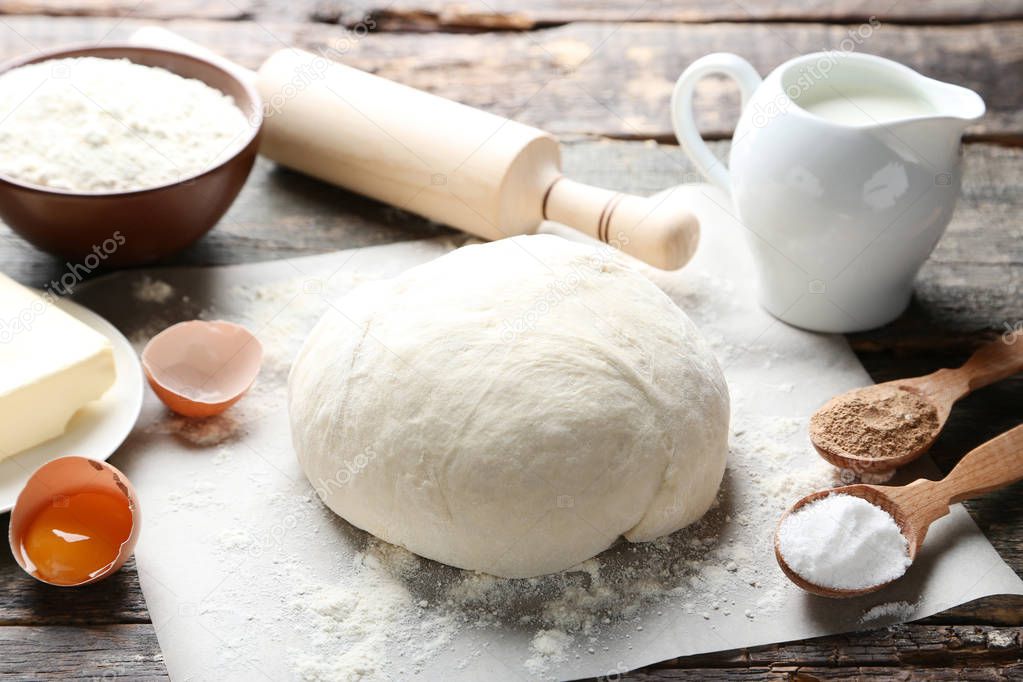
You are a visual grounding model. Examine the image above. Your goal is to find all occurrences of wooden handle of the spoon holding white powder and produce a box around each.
[934,424,1023,504]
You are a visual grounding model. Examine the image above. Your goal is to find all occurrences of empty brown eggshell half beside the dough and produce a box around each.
[142,320,263,417]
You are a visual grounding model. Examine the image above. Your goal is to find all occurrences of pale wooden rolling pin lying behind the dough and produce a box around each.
[131,27,700,270]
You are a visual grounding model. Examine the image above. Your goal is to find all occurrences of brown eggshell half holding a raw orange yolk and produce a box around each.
[8,457,142,587]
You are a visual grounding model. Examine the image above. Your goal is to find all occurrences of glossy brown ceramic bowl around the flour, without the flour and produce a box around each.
[0,45,262,269]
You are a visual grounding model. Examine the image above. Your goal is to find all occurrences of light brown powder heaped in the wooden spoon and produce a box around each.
[810,384,938,457]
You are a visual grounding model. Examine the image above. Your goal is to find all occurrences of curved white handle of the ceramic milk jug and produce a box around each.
[671,52,760,192]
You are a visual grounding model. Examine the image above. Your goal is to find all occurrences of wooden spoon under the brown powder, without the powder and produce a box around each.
[810,339,1023,480]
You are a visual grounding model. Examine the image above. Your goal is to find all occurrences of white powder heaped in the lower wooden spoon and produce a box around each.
[779,495,909,590]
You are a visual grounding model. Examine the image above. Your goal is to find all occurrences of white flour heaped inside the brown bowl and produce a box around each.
[0,57,250,193]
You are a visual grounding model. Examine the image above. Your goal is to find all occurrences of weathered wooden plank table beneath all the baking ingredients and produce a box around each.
[0,0,1023,680]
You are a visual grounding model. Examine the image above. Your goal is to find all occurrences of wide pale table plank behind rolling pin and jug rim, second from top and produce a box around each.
[0,16,1023,142]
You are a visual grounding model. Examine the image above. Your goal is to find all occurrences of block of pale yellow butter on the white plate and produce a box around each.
[0,274,117,459]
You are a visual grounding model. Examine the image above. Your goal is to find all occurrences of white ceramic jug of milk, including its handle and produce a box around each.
[671,52,984,332]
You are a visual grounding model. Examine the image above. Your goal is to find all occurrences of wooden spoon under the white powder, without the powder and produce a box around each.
[774,424,1023,597]
